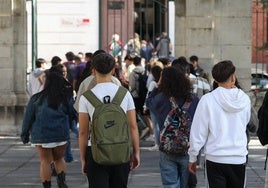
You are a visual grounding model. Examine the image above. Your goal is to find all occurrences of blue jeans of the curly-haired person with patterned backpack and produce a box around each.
[159,151,189,188]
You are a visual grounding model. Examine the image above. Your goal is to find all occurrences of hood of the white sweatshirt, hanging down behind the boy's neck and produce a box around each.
[211,87,250,112]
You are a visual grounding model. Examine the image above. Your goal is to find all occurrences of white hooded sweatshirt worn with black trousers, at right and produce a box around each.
[188,87,251,164]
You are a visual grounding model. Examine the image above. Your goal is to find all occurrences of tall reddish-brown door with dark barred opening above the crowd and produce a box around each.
[99,0,168,55]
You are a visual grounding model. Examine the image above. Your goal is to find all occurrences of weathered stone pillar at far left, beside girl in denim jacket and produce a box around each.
[0,0,28,135]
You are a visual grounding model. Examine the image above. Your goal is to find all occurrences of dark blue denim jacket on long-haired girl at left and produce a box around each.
[21,96,74,144]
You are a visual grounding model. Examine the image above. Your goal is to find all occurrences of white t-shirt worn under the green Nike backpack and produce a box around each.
[79,82,135,145]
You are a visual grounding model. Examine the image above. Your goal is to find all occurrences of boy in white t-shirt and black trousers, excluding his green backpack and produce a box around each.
[79,53,140,188]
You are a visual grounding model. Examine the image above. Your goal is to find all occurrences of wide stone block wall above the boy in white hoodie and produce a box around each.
[175,0,252,91]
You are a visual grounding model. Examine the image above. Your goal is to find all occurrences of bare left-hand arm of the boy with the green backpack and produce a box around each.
[79,112,90,175]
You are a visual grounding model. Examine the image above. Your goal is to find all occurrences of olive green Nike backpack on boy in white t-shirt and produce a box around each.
[83,87,130,165]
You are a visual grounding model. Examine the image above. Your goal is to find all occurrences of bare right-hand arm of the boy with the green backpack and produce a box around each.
[127,109,140,170]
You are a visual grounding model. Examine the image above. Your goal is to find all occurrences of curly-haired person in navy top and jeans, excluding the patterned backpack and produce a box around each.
[146,67,198,188]
